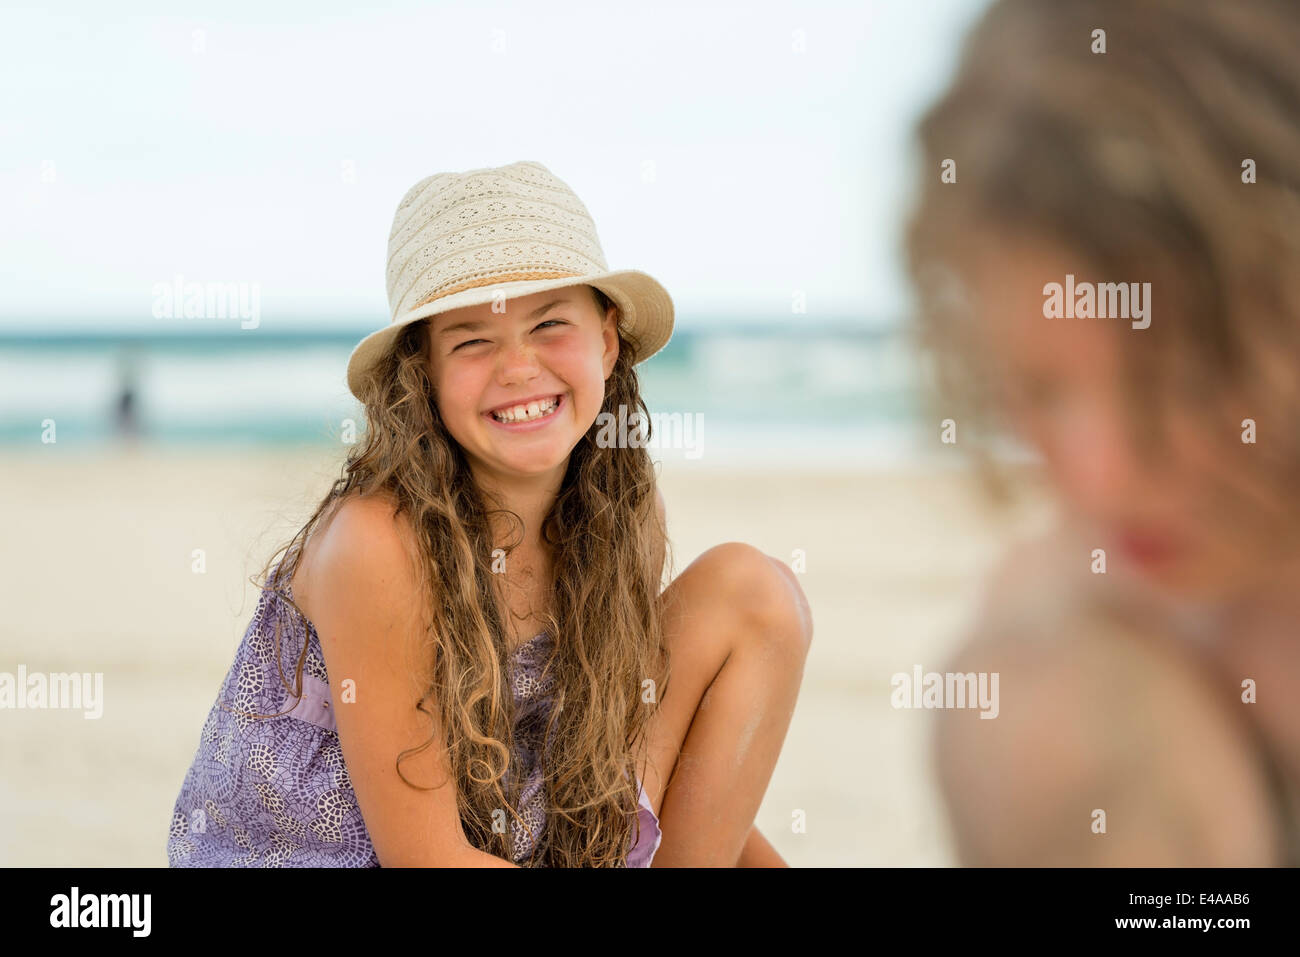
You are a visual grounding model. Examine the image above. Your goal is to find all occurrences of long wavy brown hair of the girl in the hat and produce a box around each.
[243,286,672,867]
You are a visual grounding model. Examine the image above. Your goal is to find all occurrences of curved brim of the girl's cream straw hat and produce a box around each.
[347,269,673,399]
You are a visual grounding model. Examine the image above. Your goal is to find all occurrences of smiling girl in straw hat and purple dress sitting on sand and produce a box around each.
[168,163,811,867]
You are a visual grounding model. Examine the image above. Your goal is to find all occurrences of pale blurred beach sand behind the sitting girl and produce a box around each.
[0,446,1047,866]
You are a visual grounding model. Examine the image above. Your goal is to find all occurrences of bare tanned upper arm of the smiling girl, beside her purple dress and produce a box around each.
[304,498,515,867]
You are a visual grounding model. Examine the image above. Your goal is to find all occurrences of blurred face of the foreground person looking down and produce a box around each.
[967,237,1262,598]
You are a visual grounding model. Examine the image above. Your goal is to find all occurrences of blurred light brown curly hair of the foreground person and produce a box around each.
[906,0,1300,520]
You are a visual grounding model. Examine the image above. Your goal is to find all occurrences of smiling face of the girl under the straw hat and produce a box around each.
[429,286,619,485]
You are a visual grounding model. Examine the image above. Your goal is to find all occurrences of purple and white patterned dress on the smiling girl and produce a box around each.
[166,564,663,867]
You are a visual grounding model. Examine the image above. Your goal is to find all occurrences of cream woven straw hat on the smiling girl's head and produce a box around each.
[347,161,673,398]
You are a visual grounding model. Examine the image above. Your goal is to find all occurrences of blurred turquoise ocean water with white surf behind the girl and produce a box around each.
[0,322,937,467]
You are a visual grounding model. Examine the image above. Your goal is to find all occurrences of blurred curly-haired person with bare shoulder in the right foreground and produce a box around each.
[907,0,1300,866]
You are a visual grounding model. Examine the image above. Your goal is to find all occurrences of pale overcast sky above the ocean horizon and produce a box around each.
[0,0,985,326]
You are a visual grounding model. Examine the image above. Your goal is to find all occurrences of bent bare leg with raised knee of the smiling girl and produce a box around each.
[641,542,813,867]
